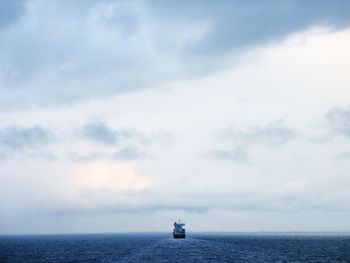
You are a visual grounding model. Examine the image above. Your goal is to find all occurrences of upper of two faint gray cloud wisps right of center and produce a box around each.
[224,120,295,147]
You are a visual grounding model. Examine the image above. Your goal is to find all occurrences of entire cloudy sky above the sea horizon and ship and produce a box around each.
[0,0,350,234]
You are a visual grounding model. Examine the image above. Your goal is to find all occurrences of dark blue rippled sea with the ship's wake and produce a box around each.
[0,234,350,263]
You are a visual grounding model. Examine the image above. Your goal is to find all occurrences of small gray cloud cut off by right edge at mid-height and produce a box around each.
[326,106,350,138]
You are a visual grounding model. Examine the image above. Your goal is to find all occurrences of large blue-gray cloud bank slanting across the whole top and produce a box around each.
[0,0,350,110]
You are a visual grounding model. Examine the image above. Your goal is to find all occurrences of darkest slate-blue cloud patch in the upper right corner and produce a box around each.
[158,0,350,55]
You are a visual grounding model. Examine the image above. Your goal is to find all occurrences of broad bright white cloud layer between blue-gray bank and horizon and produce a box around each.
[0,26,350,232]
